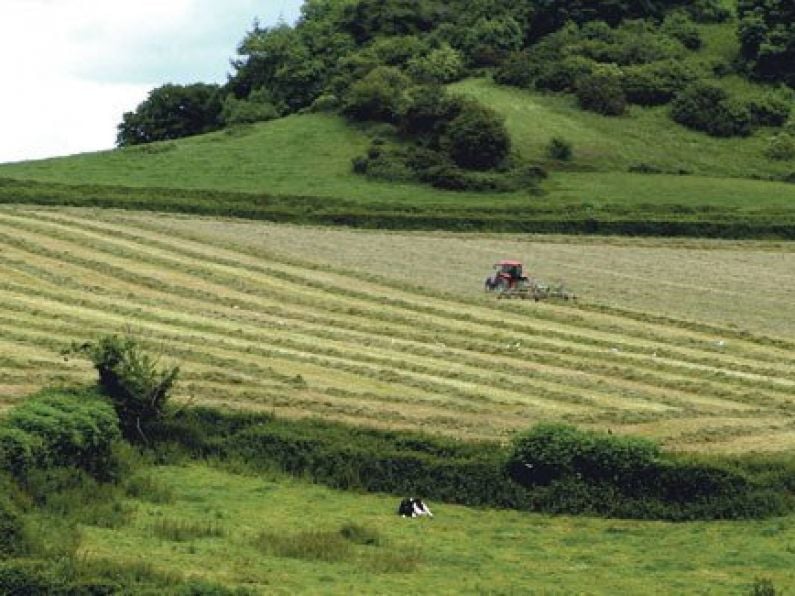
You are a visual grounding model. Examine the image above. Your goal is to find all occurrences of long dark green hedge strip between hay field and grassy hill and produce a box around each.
[0,178,795,240]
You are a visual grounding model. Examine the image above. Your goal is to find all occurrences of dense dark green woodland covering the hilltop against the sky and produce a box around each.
[118,0,795,157]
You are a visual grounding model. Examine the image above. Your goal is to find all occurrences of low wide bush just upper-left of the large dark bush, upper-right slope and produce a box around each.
[621,60,697,106]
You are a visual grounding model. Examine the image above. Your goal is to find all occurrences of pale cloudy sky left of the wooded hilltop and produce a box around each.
[0,0,302,163]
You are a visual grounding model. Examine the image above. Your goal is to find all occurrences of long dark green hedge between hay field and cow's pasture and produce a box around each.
[151,408,795,520]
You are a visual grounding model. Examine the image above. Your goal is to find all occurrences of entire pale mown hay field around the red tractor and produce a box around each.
[0,208,795,452]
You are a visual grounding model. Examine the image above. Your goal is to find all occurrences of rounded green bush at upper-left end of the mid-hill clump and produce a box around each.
[342,66,410,122]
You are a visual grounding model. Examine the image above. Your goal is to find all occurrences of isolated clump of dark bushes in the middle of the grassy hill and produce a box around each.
[341,77,522,190]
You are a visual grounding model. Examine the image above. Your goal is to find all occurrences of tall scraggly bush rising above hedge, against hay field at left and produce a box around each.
[72,335,179,441]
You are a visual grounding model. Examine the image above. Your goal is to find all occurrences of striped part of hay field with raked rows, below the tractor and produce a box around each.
[0,209,795,451]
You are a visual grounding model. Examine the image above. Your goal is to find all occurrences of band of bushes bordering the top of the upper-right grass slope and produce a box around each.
[495,12,792,136]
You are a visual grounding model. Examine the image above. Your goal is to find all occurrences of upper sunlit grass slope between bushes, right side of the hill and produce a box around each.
[452,79,795,180]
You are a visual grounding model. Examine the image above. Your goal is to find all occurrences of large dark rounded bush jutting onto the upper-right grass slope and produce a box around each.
[671,83,751,137]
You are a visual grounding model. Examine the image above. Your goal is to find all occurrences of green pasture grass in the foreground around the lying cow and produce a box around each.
[81,465,795,594]
